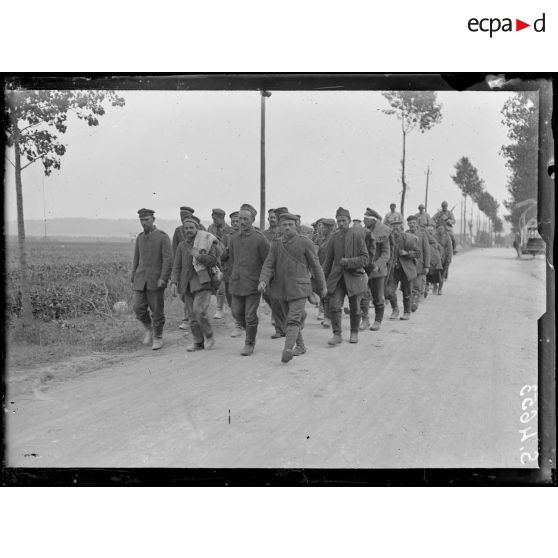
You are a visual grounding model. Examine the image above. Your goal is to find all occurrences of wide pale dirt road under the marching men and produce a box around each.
[4,249,545,468]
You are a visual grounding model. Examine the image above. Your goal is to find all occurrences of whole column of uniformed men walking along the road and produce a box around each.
[131,202,456,362]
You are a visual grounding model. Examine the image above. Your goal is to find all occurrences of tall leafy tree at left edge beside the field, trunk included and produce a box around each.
[4,88,125,325]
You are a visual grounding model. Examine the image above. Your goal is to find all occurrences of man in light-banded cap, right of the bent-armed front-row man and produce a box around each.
[360,207,391,331]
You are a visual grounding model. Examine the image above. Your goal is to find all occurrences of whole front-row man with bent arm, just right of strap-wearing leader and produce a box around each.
[324,207,368,346]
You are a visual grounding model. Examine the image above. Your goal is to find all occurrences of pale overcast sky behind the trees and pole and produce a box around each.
[6,91,524,230]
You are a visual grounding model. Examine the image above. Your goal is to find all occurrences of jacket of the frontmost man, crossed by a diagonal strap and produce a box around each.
[259,234,325,301]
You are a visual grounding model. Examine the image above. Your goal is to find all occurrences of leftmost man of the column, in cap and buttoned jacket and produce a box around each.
[130,208,172,350]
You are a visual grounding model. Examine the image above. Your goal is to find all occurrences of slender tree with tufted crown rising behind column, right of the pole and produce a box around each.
[382,91,442,215]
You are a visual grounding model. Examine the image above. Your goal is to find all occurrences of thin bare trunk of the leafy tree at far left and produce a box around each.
[11,109,33,326]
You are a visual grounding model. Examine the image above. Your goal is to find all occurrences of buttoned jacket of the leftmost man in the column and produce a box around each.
[131,229,172,291]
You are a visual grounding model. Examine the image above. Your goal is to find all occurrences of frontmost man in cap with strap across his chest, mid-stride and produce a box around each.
[258,213,326,362]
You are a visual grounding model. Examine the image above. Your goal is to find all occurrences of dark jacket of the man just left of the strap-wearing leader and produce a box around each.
[229,228,269,296]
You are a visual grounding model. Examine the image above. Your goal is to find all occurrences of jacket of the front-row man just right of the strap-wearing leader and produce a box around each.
[323,228,369,296]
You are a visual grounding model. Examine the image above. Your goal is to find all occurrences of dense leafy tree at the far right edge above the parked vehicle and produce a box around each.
[500,91,539,231]
